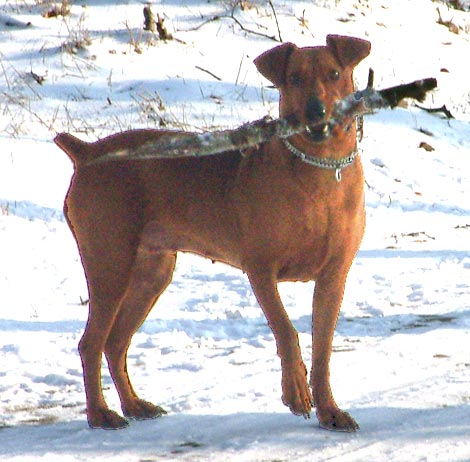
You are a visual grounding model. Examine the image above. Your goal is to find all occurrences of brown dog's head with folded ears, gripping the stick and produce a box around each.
[255,35,370,142]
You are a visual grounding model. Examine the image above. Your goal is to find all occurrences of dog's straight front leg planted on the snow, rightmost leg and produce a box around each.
[310,268,359,432]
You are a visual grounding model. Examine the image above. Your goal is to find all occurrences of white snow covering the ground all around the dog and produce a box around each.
[0,0,470,462]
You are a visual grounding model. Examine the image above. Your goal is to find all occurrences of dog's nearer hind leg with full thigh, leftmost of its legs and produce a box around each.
[64,166,147,429]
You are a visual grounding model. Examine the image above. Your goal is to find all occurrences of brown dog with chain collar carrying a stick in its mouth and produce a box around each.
[55,35,370,431]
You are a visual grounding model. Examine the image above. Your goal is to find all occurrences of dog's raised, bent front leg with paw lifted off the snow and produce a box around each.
[248,272,313,418]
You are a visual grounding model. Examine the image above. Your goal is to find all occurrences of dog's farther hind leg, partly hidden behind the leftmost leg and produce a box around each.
[105,246,176,419]
